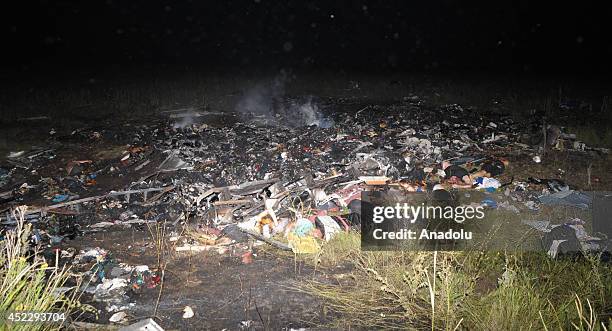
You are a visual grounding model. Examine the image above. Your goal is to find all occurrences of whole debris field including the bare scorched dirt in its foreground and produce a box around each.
[0,96,609,328]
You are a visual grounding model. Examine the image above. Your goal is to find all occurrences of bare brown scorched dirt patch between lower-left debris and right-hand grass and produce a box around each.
[65,230,334,330]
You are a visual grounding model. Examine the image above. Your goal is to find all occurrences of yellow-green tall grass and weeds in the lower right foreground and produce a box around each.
[299,233,612,330]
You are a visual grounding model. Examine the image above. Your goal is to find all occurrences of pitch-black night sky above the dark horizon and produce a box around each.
[0,0,612,73]
